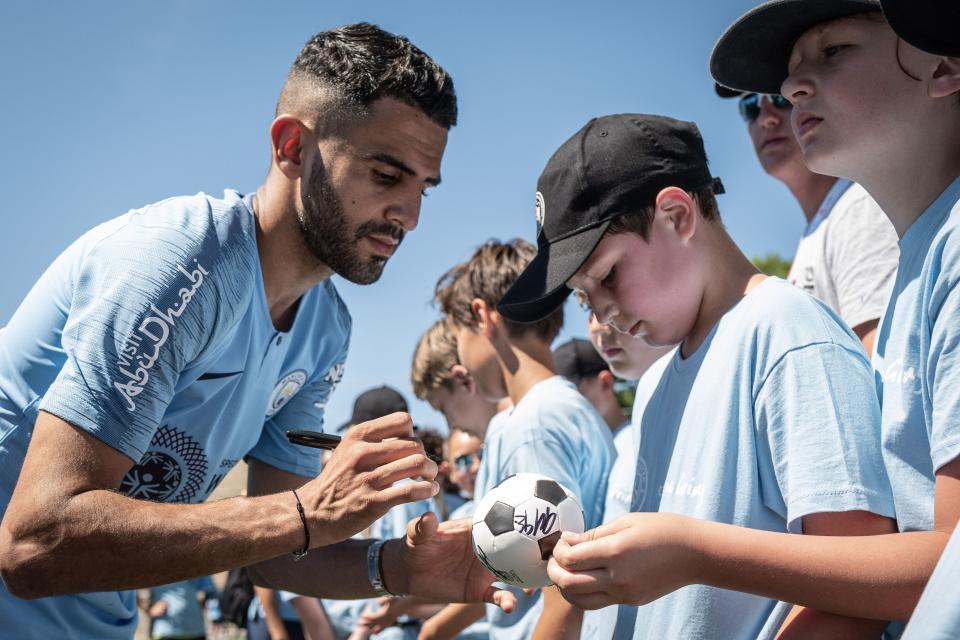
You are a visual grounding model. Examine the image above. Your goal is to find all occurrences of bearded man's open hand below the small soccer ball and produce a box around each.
[383,512,517,613]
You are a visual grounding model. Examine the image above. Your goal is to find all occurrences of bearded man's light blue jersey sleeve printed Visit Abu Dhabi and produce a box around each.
[40,212,243,461]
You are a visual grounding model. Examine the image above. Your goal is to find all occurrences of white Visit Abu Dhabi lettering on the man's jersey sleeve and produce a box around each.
[113,260,209,412]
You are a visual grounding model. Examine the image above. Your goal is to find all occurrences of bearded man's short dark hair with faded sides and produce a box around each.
[277,22,457,129]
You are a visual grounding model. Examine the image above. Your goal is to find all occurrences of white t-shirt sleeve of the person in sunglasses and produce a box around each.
[826,191,900,327]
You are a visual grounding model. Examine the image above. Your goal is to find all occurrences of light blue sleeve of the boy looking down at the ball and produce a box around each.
[755,343,894,532]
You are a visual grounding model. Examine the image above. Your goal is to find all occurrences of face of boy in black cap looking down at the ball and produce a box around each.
[567,224,702,347]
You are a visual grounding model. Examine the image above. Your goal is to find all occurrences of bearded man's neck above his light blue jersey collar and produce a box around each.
[253,179,332,331]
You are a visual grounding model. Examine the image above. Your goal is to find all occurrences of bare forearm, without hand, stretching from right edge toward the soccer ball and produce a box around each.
[691,521,949,620]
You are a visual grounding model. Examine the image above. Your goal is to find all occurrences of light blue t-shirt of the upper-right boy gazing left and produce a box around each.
[873,178,960,531]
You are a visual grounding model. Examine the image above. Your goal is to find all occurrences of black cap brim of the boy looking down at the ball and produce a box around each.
[497,220,610,322]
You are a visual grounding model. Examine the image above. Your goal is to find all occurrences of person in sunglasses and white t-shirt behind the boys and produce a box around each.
[716,85,899,354]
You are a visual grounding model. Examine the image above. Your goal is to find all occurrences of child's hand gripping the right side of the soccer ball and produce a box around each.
[547,513,697,609]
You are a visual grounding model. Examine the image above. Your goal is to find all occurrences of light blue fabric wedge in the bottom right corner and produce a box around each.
[903,529,960,640]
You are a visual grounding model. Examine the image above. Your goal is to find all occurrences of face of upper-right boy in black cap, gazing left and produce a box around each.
[782,14,925,179]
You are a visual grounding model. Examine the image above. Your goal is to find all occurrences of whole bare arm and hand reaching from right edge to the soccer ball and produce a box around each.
[548,459,960,620]
